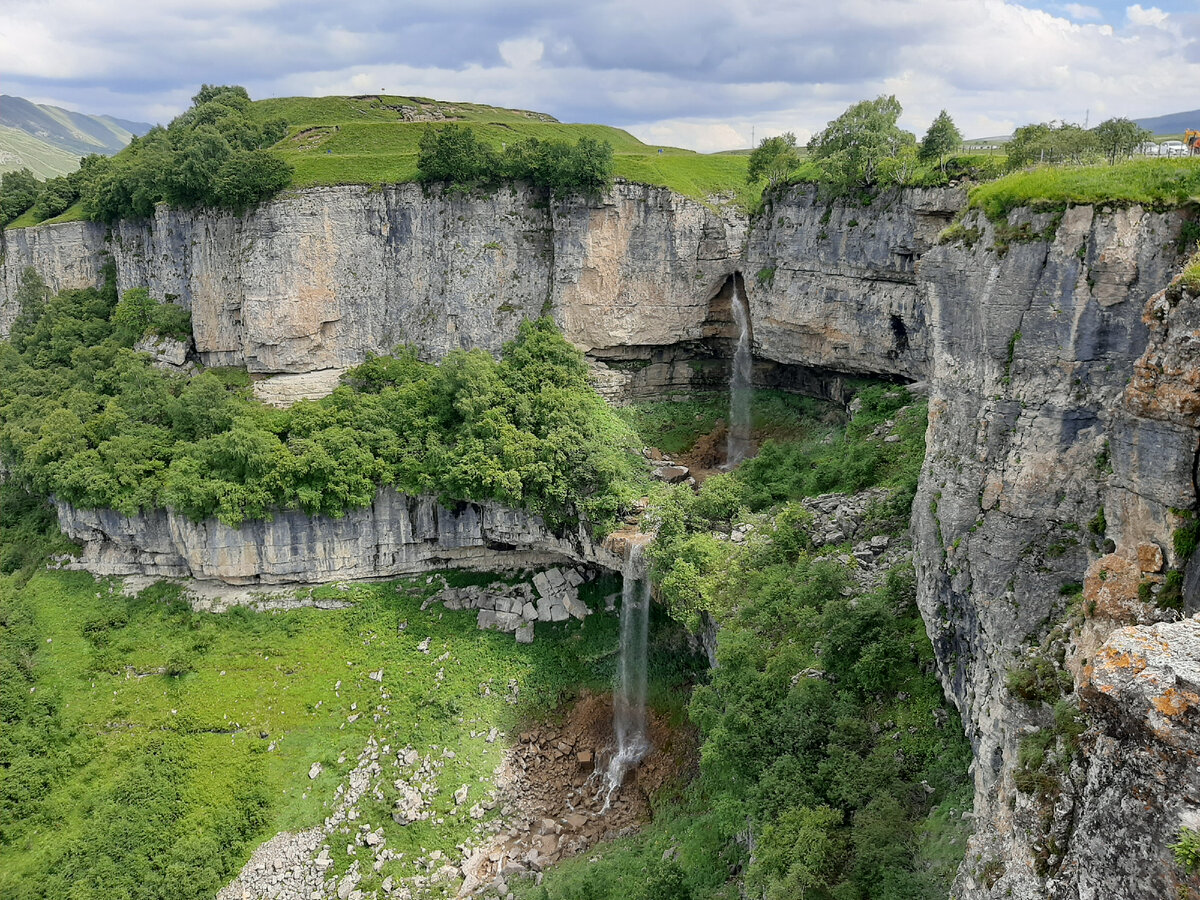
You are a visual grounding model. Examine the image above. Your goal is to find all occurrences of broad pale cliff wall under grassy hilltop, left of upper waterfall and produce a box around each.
[105,185,745,373]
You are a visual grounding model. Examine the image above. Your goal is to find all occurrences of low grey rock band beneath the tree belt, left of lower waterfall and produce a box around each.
[56,487,620,584]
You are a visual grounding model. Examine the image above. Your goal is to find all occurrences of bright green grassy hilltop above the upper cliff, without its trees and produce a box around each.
[253,95,751,203]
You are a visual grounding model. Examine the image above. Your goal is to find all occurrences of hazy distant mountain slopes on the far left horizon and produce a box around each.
[0,94,151,178]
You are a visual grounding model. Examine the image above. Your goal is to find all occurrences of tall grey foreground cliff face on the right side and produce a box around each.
[913,206,1196,898]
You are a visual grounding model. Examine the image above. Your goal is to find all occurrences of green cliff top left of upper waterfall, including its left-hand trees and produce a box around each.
[0,85,761,228]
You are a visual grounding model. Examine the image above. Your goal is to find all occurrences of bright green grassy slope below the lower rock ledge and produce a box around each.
[0,571,679,900]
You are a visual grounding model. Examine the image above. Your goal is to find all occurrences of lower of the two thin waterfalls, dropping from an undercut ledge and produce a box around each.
[606,544,650,805]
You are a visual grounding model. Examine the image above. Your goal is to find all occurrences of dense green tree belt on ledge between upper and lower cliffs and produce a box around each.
[0,267,641,532]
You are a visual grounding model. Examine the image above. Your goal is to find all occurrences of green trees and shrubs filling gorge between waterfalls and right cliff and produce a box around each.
[523,386,971,900]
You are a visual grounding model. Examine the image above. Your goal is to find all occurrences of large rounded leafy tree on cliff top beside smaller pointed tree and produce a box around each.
[809,96,917,193]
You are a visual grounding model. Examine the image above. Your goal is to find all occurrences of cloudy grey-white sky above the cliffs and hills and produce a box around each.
[0,0,1200,151]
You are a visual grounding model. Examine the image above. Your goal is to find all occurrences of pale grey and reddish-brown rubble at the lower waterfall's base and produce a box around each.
[217,695,696,900]
